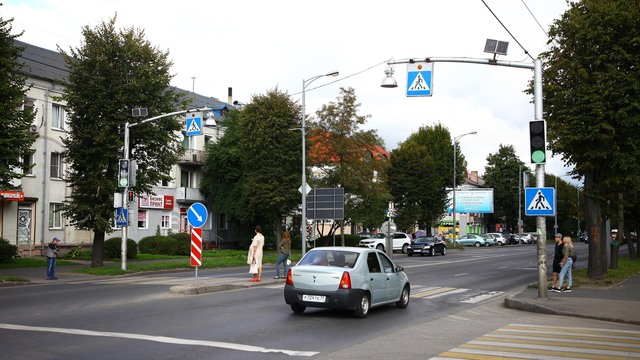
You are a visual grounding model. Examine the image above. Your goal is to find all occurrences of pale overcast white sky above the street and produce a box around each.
[0,0,578,186]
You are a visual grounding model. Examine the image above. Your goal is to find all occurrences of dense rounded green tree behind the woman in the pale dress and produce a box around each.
[201,89,302,238]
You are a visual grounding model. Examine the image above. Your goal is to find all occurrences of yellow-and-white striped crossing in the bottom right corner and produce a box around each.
[431,324,640,360]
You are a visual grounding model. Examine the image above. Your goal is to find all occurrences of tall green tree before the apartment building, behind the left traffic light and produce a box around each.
[60,17,182,267]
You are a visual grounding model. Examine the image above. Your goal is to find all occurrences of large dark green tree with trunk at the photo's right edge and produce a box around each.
[541,0,640,279]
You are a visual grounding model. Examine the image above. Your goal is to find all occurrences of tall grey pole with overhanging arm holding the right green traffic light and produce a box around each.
[387,57,547,298]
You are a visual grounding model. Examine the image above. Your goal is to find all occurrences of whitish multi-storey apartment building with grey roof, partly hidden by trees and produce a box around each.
[0,40,231,254]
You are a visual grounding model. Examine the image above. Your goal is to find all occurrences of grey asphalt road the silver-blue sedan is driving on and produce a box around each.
[0,240,637,360]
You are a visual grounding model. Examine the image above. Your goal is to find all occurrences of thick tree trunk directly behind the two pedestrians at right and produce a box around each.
[584,170,607,280]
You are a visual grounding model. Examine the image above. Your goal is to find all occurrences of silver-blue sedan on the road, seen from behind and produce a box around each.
[284,247,411,318]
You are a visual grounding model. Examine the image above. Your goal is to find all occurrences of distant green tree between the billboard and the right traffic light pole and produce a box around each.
[484,144,524,232]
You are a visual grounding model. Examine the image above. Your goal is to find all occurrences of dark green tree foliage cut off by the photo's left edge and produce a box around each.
[0,13,36,189]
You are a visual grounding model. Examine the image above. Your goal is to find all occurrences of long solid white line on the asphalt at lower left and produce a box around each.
[0,323,319,357]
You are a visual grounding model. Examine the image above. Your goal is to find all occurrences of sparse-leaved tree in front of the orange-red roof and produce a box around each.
[307,88,390,239]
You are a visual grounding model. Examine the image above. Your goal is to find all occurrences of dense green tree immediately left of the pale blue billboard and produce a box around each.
[389,124,452,230]
